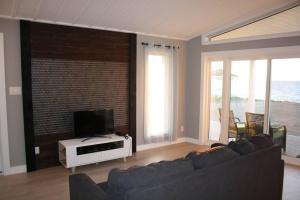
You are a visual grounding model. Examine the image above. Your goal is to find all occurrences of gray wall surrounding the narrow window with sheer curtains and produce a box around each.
[136,35,186,145]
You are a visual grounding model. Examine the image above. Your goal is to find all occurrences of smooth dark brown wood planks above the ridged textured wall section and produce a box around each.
[31,23,129,63]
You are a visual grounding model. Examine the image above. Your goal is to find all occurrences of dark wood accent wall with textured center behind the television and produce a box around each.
[20,21,136,171]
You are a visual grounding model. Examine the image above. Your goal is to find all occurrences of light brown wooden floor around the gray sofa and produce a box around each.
[0,143,300,200]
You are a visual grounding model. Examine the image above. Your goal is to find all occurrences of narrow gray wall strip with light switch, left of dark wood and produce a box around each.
[0,19,26,167]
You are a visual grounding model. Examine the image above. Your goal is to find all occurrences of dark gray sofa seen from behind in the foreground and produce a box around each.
[69,136,284,200]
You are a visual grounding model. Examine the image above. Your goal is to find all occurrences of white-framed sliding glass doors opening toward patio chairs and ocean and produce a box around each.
[199,47,300,164]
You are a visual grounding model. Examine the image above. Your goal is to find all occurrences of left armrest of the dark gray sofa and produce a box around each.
[69,174,108,200]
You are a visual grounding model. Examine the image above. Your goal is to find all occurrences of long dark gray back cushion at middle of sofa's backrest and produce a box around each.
[186,146,239,169]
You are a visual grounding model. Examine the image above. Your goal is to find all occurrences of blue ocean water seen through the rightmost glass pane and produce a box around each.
[271,81,300,103]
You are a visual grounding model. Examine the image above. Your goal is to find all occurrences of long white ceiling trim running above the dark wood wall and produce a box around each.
[0,15,188,41]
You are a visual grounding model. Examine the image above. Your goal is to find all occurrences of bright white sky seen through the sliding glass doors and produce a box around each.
[211,58,300,99]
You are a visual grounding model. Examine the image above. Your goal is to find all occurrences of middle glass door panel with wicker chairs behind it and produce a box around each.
[228,60,267,140]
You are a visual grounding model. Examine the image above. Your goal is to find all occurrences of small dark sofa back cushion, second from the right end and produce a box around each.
[228,139,256,155]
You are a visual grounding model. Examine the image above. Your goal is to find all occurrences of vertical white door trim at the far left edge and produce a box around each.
[0,33,10,175]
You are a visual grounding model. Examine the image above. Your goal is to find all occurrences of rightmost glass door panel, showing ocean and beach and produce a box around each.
[269,58,300,157]
